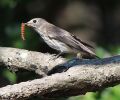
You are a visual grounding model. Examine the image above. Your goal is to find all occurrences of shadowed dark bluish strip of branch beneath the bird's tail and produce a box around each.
[48,56,120,75]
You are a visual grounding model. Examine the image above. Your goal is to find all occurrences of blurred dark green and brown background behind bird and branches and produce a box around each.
[0,0,120,100]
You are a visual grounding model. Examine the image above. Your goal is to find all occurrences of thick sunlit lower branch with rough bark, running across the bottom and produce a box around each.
[0,57,120,100]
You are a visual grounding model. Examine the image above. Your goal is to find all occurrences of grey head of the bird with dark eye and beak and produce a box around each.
[25,18,46,29]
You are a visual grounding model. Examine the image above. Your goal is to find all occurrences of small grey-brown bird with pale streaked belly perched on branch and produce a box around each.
[25,18,98,59]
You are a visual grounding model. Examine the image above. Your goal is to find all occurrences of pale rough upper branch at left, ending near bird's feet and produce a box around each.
[0,47,66,76]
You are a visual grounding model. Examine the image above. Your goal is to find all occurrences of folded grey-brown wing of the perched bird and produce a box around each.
[47,26,95,55]
